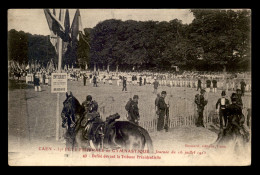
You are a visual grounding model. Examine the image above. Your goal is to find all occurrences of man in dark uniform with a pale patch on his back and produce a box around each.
[216,91,229,129]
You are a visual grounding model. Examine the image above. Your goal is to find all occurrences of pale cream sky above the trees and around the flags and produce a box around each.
[8,9,194,35]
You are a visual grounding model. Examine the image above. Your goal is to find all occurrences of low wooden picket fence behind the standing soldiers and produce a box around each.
[96,97,251,132]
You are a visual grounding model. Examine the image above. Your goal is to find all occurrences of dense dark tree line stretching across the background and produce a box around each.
[8,10,251,71]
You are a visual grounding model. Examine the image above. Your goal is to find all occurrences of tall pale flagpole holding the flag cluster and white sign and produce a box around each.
[56,9,63,141]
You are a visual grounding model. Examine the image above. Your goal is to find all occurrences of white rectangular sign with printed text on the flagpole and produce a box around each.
[51,73,68,93]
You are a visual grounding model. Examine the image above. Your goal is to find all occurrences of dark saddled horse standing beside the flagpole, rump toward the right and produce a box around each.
[61,92,153,153]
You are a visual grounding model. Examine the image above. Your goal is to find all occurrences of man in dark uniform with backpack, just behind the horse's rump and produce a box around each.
[127,95,140,125]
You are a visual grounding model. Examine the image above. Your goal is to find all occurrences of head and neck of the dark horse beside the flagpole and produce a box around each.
[61,92,81,128]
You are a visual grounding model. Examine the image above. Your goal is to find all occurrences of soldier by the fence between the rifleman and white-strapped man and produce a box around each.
[195,89,208,127]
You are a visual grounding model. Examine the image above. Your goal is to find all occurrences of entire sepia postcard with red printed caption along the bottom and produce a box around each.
[8,8,252,166]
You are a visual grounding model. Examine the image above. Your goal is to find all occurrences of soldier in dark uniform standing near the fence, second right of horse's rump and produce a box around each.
[157,91,167,131]
